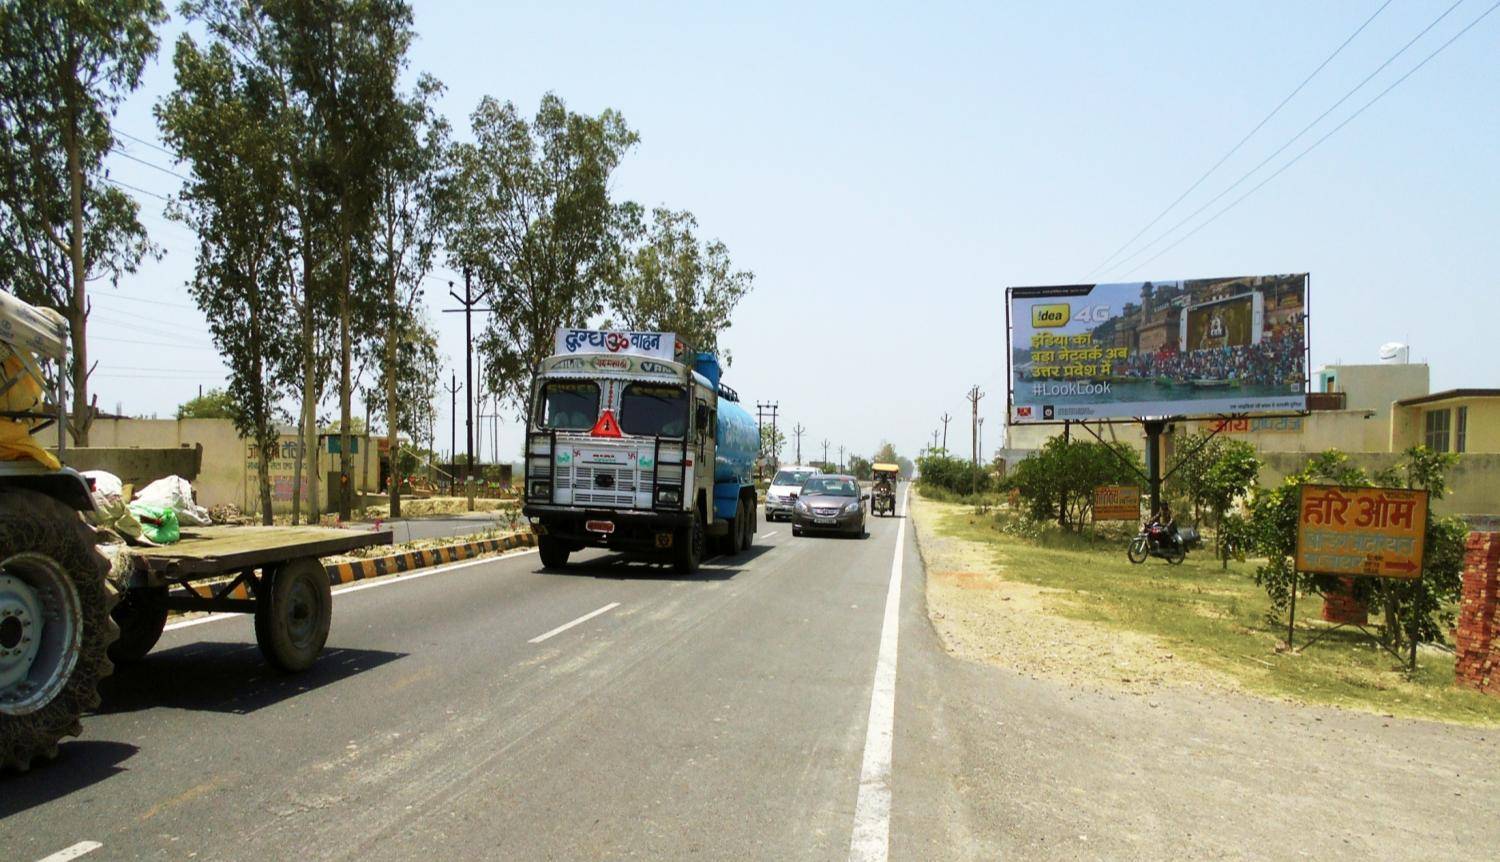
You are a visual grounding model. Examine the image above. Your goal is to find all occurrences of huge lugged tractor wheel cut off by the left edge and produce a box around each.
[0,490,119,769]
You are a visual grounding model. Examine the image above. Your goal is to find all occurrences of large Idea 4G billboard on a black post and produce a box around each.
[1005,273,1308,424]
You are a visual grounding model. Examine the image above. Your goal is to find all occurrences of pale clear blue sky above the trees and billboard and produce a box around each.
[92,0,1500,459]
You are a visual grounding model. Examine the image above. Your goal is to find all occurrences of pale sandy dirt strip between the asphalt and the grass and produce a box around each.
[909,495,1239,693]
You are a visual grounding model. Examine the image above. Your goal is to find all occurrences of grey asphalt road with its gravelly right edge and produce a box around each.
[0,485,1500,862]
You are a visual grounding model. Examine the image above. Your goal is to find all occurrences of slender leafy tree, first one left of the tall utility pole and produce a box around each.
[374,75,449,517]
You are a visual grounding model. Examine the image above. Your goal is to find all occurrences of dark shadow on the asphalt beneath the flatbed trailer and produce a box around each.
[99,642,407,715]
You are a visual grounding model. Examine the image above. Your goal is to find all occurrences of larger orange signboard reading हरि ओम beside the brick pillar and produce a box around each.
[1298,484,1427,580]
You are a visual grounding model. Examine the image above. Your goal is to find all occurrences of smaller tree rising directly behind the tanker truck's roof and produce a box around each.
[609,207,755,364]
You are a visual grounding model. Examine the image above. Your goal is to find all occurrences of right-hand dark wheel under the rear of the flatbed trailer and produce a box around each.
[255,556,333,672]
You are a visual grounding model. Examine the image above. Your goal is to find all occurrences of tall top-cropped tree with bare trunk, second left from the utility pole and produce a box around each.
[267,0,413,519]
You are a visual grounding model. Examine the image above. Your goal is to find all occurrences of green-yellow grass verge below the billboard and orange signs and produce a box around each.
[914,488,1500,724]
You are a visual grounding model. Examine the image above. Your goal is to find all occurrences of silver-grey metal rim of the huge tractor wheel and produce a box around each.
[0,553,83,715]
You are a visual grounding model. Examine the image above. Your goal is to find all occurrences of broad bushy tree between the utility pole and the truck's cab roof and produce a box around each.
[444,93,638,405]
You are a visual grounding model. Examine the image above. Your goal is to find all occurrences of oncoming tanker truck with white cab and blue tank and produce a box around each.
[522,328,761,574]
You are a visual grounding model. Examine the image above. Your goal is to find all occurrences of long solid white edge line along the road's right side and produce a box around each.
[849,490,911,862]
